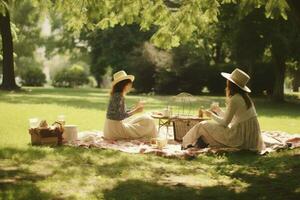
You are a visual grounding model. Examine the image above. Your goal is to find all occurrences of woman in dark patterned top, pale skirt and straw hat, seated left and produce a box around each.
[104,71,157,139]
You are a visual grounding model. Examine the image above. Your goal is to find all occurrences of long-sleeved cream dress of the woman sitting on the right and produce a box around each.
[182,94,264,151]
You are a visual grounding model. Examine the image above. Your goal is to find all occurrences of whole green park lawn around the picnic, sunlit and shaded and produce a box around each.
[0,88,300,199]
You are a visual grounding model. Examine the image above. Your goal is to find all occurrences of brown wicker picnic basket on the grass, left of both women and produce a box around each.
[29,122,64,145]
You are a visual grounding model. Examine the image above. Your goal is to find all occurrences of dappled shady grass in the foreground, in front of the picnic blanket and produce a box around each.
[0,147,300,199]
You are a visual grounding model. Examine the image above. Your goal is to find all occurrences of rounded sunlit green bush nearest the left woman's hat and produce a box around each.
[52,65,89,88]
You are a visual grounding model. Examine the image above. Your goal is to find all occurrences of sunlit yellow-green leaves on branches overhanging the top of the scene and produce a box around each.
[50,0,289,49]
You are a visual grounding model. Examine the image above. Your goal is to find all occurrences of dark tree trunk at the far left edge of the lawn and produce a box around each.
[0,10,19,90]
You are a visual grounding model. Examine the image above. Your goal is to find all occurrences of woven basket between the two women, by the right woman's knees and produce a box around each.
[172,118,204,142]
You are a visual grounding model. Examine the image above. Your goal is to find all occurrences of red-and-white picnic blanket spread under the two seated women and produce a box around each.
[65,131,300,159]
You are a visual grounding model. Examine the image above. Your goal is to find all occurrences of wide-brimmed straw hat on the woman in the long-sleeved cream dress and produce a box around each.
[221,68,251,93]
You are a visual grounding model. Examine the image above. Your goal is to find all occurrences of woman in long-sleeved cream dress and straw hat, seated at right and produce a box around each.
[182,69,264,152]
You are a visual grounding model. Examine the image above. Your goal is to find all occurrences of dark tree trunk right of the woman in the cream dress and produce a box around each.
[272,55,286,102]
